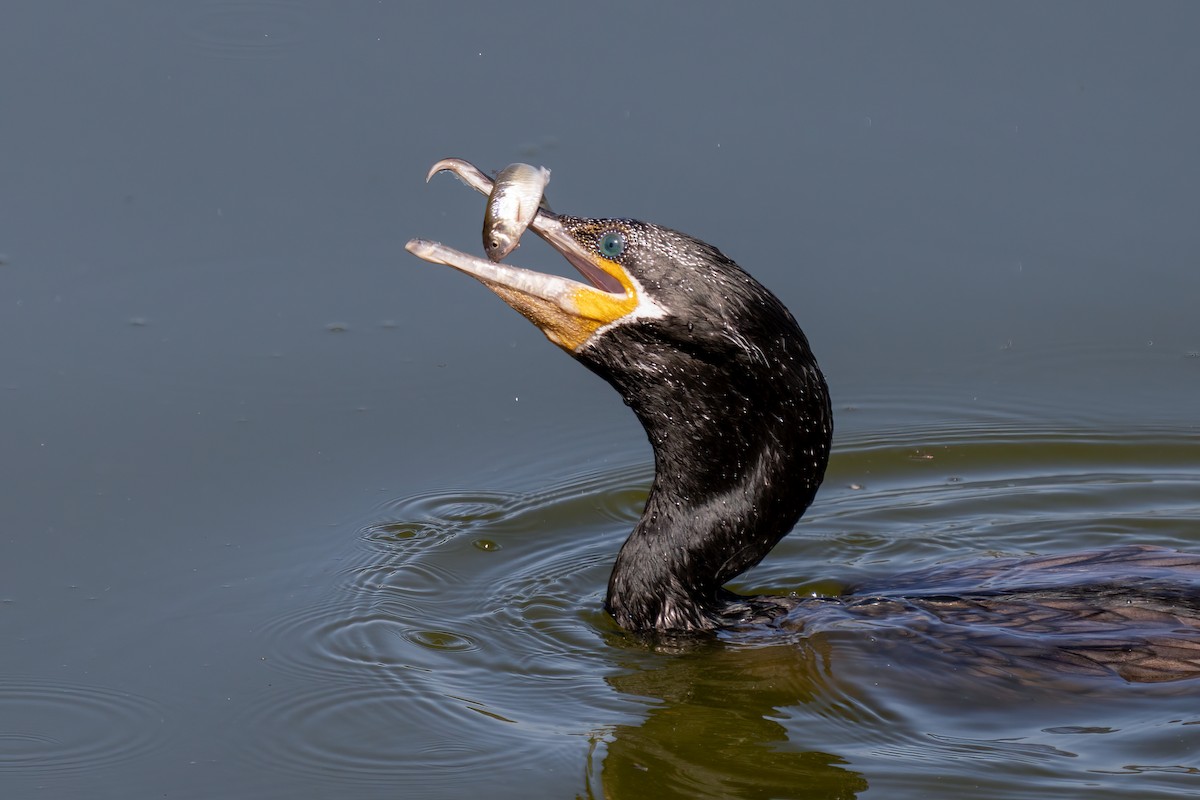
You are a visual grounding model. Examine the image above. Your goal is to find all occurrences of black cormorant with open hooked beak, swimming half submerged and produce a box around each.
[408,158,1200,681]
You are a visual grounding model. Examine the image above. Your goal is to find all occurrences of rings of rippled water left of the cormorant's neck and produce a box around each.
[238,465,649,790]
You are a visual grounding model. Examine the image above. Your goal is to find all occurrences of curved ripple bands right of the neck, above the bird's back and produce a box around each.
[763,425,1200,587]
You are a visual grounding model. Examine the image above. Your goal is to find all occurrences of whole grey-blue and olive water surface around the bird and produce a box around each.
[0,0,1200,799]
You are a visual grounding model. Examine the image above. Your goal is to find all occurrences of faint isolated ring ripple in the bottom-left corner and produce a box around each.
[0,676,164,774]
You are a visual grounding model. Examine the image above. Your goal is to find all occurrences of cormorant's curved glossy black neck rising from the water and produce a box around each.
[583,319,832,631]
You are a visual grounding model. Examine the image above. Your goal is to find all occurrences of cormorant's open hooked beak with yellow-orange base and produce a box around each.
[406,158,640,353]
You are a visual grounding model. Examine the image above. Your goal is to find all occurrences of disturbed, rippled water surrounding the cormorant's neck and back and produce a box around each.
[229,426,1200,798]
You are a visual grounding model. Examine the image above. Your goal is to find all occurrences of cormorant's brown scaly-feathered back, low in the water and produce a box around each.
[734,546,1200,682]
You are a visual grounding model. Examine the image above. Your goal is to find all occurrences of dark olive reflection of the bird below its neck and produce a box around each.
[601,643,868,798]
